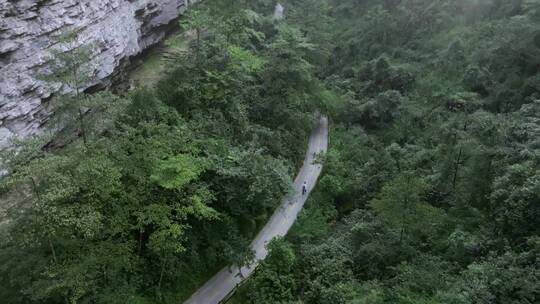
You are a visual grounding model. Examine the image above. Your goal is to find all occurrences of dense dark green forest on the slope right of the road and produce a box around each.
[235,0,540,304]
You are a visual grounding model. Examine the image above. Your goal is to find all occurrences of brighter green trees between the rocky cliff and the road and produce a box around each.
[0,1,319,304]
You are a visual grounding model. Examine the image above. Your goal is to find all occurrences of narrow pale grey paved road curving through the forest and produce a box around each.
[184,117,328,304]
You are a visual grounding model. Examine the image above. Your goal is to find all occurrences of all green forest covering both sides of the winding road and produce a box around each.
[0,0,540,304]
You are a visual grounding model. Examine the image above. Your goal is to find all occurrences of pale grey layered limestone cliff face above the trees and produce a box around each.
[0,0,194,147]
